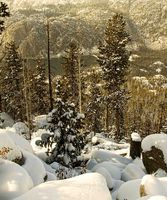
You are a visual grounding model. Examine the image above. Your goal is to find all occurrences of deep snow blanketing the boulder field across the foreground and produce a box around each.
[0,122,167,200]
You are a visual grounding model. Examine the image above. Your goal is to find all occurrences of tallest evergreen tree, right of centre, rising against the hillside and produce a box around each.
[98,14,130,138]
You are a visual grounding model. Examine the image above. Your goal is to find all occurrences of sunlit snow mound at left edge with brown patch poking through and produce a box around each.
[0,129,22,161]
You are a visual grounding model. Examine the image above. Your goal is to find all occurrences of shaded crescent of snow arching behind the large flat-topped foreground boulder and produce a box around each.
[92,161,121,180]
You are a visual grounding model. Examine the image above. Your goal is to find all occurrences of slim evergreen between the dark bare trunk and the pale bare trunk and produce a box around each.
[63,41,81,111]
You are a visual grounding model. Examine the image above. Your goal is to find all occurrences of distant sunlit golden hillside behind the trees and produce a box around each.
[3,0,167,74]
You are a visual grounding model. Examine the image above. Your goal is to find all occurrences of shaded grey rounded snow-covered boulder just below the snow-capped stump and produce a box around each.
[122,163,145,181]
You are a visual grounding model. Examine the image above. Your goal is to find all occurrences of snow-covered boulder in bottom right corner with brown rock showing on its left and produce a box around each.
[140,175,167,197]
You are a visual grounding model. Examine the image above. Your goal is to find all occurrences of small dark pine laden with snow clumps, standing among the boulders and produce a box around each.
[44,99,84,167]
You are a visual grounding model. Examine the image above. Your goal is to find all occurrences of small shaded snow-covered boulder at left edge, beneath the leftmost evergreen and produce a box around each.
[0,112,14,128]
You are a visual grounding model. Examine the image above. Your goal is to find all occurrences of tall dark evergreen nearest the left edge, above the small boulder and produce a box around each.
[1,42,25,120]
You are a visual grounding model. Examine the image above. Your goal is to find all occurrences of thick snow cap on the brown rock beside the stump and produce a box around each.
[141,133,167,164]
